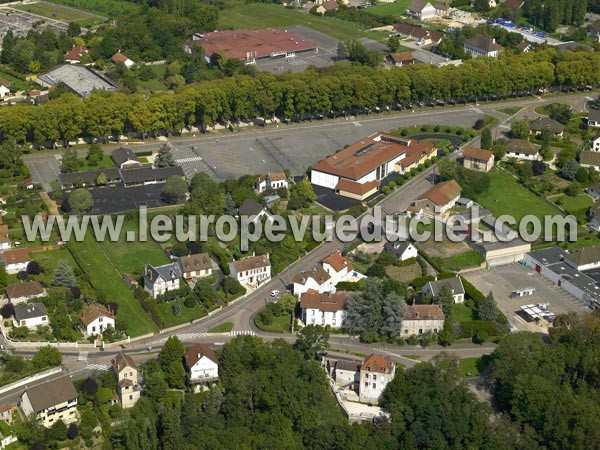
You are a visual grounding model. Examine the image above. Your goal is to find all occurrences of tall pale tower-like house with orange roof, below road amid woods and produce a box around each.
[358,355,396,404]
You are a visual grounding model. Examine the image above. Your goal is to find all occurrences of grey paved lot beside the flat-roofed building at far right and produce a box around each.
[463,264,589,331]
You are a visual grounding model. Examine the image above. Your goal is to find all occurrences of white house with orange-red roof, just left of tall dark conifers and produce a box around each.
[300,289,350,328]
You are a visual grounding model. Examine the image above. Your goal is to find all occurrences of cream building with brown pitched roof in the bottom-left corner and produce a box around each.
[19,376,78,428]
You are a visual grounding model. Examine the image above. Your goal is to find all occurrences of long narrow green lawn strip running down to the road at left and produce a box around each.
[69,237,157,337]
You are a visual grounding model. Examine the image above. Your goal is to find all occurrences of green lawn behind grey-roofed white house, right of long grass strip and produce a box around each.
[97,219,169,277]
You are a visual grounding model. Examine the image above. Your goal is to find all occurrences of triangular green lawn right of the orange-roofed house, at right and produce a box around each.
[474,170,560,223]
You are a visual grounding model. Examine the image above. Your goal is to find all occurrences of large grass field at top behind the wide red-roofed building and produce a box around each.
[219,3,380,41]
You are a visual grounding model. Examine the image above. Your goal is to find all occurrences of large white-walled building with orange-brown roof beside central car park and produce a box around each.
[310,133,435,200]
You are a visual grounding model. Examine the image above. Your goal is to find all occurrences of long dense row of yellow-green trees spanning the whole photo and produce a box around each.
[0,48,600,146]
